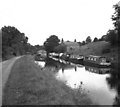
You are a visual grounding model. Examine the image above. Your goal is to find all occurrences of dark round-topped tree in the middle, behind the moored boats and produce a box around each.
[44,35,60,56]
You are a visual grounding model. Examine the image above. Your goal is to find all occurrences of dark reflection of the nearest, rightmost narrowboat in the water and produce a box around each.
[85,66,111,74]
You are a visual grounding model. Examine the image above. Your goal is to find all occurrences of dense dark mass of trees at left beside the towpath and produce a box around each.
[1,26,40,60]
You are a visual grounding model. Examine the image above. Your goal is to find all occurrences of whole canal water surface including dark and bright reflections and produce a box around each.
[34,59,119,105]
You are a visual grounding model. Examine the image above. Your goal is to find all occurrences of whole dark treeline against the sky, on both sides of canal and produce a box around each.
[1,4,120,60]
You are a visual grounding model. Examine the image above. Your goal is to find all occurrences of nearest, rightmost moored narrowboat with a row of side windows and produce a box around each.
[84,55,111,67]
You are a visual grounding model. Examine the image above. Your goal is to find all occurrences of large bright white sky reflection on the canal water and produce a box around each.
[56,67,116,105]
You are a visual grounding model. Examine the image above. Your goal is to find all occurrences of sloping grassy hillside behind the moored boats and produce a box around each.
[67,41,120,68]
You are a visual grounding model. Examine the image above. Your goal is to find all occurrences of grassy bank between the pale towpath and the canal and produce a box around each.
[3,56,93,105]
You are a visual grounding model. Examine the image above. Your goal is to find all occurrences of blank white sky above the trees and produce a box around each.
[0,0,119,45]
